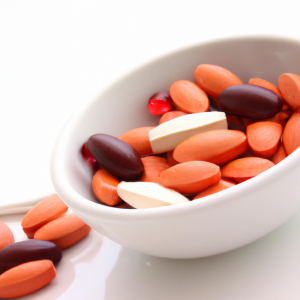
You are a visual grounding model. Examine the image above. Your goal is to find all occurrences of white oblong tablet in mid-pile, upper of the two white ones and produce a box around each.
[149,111,228,153]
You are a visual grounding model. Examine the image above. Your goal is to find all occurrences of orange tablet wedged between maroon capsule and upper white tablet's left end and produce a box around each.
[119,126,155,156]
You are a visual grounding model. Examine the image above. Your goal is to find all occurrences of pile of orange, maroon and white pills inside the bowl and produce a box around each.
[81,64,300,208]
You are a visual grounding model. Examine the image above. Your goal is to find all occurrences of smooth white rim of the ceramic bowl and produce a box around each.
[50,35,300,222]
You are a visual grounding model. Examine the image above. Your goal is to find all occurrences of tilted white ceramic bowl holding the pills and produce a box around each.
[51,37,300,258]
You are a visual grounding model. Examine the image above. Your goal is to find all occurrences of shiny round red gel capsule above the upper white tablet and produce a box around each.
[148,92,173,115]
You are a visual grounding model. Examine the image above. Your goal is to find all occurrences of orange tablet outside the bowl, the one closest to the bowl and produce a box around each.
[34,214,91,249]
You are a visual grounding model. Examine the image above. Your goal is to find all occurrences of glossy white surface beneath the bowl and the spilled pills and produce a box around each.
[0,212,300,300]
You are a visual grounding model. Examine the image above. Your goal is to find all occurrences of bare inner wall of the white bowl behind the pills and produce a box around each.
[56,37,300,209]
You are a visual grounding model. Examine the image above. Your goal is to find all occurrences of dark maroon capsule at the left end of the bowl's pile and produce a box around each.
[87,133,144,181]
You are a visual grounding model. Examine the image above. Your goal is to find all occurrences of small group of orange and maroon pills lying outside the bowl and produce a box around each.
[0,195,91,299]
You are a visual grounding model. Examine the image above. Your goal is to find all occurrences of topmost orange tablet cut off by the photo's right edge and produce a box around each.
[278,73,300,110]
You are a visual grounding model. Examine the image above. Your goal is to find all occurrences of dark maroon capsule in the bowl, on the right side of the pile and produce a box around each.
[220,84,282,120]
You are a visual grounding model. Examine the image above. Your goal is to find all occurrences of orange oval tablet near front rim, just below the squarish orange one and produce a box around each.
[222,157,274,180]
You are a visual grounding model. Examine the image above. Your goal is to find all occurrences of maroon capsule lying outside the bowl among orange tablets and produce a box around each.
[0,240,62,274]
